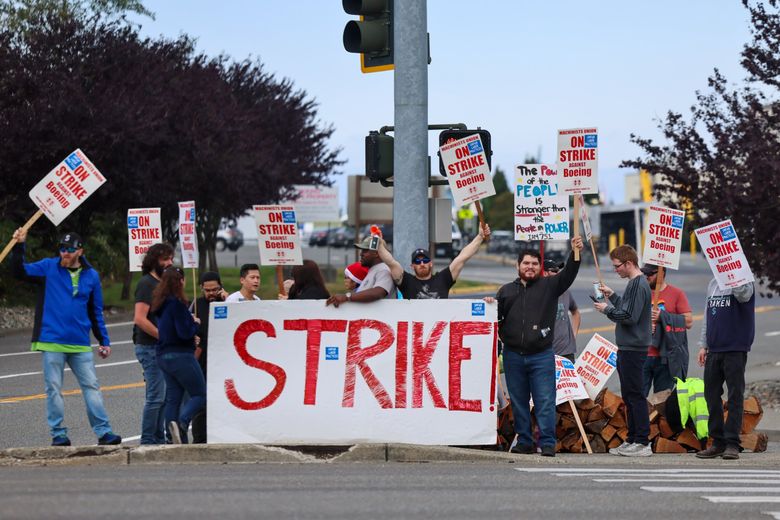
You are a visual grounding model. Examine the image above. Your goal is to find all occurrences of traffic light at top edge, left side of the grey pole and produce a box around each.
[341,0,393,72]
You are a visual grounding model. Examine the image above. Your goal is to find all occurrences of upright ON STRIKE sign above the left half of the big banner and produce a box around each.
[253,205,303,265]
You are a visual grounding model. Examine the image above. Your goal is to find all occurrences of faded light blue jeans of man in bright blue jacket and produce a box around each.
[43,351,111,439]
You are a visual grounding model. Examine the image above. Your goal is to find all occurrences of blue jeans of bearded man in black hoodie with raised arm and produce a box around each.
[504,348,555,447]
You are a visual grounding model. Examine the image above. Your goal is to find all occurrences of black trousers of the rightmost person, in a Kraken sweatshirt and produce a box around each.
[704,352,747,449]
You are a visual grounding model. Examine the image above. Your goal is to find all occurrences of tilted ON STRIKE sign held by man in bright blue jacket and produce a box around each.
[29,150,106,226]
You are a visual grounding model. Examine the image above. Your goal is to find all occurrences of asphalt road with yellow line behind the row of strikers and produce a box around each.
[0,246,780,449]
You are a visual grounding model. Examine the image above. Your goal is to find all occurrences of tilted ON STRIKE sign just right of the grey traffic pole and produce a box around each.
[439,134,496,208]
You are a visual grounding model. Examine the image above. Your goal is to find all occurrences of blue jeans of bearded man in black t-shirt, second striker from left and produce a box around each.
[135,345,165,444]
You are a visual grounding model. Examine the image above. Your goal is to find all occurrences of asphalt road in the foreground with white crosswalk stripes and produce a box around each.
[0,464,780,520]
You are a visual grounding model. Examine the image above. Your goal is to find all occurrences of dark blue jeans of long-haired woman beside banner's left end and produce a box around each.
[157,352,206,428]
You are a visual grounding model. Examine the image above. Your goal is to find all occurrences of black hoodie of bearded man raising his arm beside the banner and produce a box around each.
[496,252,580,354]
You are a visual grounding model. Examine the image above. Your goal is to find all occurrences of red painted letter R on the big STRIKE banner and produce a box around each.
[341,320,395,408]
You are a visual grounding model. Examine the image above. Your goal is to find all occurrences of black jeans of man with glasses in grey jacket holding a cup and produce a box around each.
[617,350,650,446]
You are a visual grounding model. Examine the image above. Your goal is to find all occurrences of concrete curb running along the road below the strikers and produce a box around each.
[0,444,780,467]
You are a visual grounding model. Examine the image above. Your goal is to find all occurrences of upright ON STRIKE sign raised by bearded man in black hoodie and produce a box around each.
[557,128,599,195]
